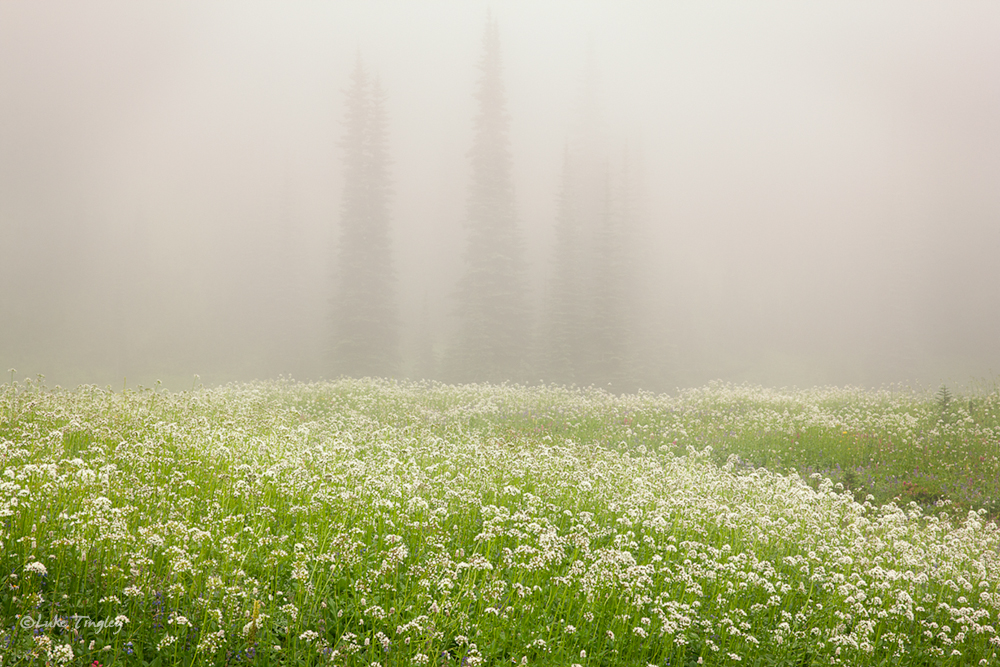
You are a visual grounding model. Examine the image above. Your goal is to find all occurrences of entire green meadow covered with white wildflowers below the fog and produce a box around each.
[0,380,1000,667]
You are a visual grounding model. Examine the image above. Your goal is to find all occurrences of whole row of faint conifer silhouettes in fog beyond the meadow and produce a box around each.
[328,18,660,390]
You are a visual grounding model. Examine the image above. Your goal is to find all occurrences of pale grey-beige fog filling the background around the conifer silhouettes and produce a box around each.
[0,0,1000,391]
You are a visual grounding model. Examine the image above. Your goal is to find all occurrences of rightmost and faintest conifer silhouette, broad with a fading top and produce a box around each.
[543,49,649,391]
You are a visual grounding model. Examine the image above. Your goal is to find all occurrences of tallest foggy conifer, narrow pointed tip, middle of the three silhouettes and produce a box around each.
[448,17,529,382]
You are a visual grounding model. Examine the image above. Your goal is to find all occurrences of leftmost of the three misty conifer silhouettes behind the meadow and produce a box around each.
[330,56,400,376]
